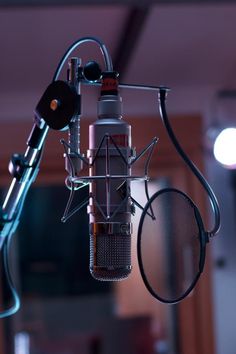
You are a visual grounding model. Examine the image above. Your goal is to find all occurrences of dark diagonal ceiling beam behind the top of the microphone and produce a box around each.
[113,7,149,80]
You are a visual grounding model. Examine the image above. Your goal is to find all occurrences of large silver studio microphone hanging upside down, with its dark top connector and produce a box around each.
[88,72,132,281]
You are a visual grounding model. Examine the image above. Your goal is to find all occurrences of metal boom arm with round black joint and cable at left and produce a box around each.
[0,76,80,318]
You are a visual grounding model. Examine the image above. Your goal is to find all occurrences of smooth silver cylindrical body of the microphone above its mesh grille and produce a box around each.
[88,118,131,222]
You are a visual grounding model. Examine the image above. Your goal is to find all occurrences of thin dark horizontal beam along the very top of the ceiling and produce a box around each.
[0,0,236,7]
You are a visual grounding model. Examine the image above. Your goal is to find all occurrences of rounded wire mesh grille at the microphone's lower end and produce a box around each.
[90,223,131,281]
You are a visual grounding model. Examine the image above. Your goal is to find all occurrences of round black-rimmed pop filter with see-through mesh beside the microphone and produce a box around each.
[137,188,207,303]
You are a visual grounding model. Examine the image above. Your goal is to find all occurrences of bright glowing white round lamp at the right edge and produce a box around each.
[214,128,236,169]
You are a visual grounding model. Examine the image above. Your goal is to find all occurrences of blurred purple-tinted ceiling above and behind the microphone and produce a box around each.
[0,3,236,121]
